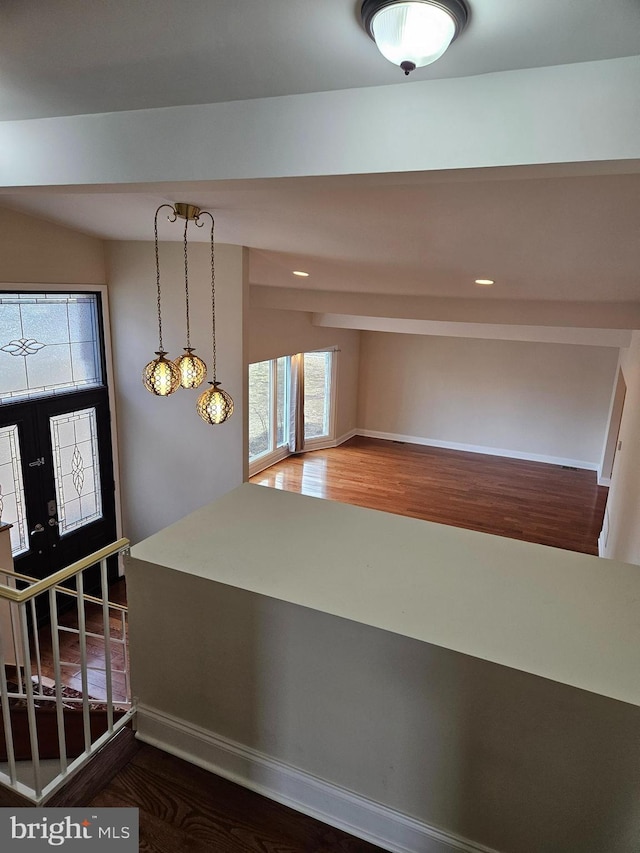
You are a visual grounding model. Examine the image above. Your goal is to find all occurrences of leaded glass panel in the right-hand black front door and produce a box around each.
[49,408,102,536]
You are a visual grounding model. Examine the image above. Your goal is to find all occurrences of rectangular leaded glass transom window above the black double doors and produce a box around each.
[0,293,103,403]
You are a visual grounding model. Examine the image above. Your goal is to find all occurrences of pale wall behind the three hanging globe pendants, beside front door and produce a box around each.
[107,242,245,542]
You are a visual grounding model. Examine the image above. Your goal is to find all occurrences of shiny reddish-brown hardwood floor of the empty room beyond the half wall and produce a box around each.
[251,436,608,554]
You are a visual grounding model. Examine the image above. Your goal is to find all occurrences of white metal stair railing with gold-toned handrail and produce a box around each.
[0,539,135,803]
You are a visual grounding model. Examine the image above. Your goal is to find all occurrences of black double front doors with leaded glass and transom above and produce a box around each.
[0,293,116,578]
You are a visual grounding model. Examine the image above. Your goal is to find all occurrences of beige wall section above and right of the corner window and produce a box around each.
[247,306,360,438]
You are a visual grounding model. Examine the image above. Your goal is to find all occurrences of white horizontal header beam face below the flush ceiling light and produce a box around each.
[0,56,640,187]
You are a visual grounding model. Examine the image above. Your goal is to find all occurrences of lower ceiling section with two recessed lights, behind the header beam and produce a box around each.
[0,168,640,301]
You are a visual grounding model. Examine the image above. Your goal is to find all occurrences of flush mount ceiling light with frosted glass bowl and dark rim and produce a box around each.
[360,0,469,75]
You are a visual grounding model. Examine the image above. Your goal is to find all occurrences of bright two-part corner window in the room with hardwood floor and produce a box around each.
[249,351,334,466]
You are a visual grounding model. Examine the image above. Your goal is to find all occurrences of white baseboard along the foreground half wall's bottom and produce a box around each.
[136,704,497,853]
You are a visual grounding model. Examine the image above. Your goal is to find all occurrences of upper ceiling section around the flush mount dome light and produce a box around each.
[0,0,640,120]
